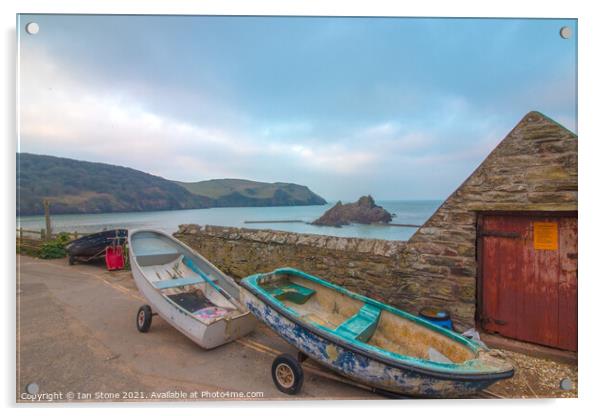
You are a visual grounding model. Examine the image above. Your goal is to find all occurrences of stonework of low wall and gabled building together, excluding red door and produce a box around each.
[176,112,577,329]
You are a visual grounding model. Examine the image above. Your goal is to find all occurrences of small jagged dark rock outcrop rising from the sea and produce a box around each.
[312,195,393,227]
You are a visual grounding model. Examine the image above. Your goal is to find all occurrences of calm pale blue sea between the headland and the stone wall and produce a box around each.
[17,201,442,240]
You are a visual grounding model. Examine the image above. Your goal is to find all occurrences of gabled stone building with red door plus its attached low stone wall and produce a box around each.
[176,112,577,351]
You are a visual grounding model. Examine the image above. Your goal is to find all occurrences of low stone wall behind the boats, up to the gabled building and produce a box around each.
[174,224,406,301]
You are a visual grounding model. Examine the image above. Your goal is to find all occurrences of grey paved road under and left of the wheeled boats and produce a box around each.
[17,256,382,402]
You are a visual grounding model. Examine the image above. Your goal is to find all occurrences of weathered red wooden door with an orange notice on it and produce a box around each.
[478,213,577,351]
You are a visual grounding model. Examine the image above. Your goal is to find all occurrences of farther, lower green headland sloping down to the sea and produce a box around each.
[177,179,326,207]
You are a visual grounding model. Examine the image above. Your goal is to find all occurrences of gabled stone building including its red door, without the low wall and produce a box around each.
[400,112,577,350]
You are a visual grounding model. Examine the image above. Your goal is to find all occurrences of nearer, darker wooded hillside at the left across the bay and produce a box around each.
[17,153,212,215]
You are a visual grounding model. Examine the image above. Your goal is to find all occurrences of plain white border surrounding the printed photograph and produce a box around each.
[0,0,602,415]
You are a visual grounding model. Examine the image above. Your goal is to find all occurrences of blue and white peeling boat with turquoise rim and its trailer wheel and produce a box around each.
[241,268,514,397]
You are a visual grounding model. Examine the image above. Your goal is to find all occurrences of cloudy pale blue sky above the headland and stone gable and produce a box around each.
[18,15,577,201]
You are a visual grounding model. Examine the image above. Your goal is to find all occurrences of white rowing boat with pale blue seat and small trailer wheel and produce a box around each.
[128,230,257,349]
